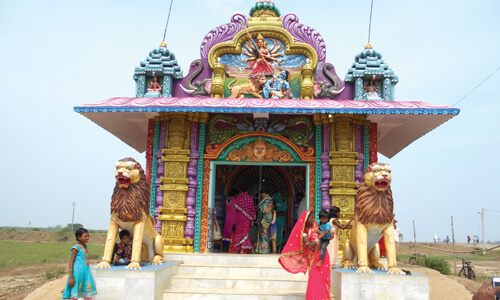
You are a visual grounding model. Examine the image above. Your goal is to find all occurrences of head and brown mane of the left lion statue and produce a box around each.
[111,157,151,222]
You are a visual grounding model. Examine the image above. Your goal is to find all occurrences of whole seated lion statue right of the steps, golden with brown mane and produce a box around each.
[340,163,405,274]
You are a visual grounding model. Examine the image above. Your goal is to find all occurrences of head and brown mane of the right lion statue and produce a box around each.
[355,163,394,224]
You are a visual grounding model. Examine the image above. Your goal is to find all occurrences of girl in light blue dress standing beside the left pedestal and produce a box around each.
[63,228,97,300]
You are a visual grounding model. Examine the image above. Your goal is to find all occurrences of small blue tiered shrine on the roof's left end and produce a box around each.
[134,42,184,98]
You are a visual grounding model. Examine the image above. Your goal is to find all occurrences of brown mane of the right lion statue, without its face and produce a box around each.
[354,172,394,224]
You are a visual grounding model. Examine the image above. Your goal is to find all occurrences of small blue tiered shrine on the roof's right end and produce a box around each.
[345,44,399,101]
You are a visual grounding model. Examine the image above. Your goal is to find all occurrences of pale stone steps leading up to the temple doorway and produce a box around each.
[163,253,322,300]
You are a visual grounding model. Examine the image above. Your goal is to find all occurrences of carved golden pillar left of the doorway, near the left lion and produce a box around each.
[159,112,193,252]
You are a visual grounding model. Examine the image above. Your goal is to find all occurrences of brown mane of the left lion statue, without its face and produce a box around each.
[111,157,151,222]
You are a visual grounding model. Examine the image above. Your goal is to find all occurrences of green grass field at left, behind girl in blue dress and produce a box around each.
[0,241,104,270]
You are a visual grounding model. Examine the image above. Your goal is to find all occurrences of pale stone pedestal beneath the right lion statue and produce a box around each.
[331,269,429,300]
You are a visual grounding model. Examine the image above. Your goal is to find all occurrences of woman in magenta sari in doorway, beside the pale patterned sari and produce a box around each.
[233,192,255,254]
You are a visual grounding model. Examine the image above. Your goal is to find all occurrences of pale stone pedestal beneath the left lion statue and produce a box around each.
[90,261,181,300]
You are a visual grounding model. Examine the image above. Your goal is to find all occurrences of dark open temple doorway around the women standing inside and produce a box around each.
[212,162,309,252]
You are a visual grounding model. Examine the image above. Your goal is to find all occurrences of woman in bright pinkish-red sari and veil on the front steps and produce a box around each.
[279,210,330,300]
